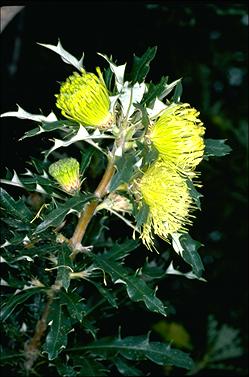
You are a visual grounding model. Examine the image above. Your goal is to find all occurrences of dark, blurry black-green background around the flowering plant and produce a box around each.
[1,1,248,375]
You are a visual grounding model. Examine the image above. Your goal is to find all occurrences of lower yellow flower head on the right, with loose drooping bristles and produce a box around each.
[138,160,194,249]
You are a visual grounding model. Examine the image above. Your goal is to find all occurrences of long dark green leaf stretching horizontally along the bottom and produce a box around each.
[71,336,193,369]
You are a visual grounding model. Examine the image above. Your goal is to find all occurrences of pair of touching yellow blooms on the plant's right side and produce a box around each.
[138,104,204,249]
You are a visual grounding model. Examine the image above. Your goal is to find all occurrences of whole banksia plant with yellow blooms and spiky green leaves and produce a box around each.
[1,42,230,377]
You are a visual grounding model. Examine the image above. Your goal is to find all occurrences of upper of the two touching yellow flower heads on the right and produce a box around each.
[150,103,205,174]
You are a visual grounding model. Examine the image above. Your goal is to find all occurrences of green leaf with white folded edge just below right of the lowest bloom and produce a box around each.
[173,233,204,278]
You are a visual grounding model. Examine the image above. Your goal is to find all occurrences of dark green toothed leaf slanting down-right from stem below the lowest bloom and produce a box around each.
[92,254,166,316]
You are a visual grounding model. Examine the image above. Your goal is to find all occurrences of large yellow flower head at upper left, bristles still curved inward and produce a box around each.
[56,68,113,128]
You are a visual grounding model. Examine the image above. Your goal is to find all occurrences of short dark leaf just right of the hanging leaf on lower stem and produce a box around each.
[60,290,86,322]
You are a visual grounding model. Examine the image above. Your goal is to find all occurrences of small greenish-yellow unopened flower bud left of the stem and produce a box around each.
[48,158,81,194]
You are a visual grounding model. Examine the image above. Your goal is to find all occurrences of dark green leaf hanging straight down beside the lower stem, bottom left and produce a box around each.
[43,300,71,360]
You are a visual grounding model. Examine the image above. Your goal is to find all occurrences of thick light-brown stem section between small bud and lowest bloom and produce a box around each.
[70,156,115,253]
